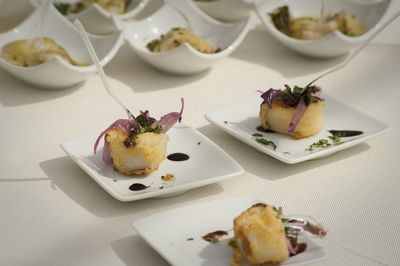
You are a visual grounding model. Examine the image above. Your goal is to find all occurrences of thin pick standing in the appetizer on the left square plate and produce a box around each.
[74,19,135,120]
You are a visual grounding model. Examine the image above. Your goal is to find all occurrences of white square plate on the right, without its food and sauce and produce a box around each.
[206,93,390,164]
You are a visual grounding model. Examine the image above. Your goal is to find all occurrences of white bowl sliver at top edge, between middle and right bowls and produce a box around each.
[192,0,253,22]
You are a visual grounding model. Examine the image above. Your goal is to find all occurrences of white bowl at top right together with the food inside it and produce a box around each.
[254,0,392,58]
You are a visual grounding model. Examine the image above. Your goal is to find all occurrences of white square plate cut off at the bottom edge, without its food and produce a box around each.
[133,197,326,266]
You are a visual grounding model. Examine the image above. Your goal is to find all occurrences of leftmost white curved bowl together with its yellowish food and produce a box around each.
[0,4,123,89]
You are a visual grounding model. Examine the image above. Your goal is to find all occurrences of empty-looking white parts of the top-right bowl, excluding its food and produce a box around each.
[254,0,392,58]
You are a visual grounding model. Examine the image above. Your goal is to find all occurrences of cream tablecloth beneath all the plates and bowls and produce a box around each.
[0,0,400,265]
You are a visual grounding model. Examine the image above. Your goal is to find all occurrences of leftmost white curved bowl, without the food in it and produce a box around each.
[0,2,123,89]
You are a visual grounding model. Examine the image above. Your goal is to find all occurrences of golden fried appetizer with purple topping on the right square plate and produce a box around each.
[260,85,325,139]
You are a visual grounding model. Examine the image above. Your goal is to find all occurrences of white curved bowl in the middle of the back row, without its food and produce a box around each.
[125,0,250,74]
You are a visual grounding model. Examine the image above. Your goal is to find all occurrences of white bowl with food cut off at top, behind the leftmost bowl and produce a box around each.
[30,0,150,35]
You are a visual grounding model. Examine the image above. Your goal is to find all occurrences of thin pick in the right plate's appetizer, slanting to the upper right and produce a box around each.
[303,10,400,91]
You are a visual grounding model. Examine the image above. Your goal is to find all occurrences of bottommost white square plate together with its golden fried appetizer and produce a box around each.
[133,197,326,265]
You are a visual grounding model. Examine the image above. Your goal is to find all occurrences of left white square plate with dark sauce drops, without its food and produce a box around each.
[61,123,244,201]
